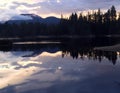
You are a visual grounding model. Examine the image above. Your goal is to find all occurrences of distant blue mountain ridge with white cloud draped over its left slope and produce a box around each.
[7,14,60,24]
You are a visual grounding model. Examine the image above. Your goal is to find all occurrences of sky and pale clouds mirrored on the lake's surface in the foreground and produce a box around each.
[0,51,120,93]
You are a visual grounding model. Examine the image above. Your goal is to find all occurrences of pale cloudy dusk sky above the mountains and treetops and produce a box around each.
[0,0,120,21]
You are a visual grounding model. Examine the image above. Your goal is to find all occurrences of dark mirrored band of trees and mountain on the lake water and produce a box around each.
[0,37,120,65]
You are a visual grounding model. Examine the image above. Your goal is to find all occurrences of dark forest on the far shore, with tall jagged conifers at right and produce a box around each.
[0,6,120,38]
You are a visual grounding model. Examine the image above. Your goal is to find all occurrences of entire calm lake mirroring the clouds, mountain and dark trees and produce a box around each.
[0,38,120,93]
